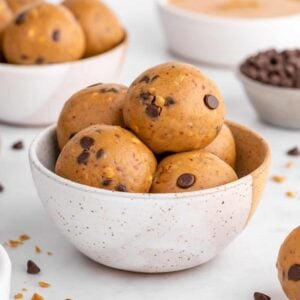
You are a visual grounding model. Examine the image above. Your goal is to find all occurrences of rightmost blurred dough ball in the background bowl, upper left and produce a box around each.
[63,0,124,56]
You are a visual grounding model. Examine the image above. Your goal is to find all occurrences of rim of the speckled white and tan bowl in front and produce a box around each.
[29,121,271,200]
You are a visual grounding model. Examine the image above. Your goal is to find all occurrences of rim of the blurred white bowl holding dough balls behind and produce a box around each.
[0,28,129,72]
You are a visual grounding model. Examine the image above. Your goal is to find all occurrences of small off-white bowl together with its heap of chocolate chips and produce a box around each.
[238,49,300,129]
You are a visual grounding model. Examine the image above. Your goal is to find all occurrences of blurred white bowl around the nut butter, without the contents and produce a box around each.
[157,0,300,66]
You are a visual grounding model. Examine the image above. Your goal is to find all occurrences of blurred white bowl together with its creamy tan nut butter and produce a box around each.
[157,0,300,67]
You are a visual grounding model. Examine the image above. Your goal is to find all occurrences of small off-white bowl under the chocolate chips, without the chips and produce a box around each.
[237,70,300,129]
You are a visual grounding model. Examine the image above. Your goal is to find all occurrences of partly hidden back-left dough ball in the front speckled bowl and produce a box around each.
[57,84,127,149]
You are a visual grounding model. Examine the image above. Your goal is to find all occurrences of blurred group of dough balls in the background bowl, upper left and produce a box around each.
[0,0,125,65]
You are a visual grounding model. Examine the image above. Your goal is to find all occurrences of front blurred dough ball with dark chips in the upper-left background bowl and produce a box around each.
[4,3,85,64]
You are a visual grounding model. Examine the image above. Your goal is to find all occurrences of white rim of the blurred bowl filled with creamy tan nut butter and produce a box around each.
[156,0,300,26]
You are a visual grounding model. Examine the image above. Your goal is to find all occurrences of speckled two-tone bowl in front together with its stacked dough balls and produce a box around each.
[29,62,270,273]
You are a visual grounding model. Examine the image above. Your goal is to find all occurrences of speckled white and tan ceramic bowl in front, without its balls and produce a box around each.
[29,122,270,273]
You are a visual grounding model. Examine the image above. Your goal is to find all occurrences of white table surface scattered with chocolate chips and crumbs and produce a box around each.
[0,0,300,300]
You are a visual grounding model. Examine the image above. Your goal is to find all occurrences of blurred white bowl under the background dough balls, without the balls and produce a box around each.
[0,38,127,126]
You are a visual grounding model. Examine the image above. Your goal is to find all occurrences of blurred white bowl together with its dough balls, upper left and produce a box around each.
[0,0,127,126]
